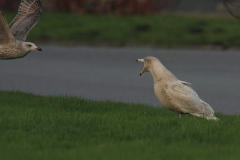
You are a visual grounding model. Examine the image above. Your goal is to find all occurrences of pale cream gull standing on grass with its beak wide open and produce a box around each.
[137,57,218,120]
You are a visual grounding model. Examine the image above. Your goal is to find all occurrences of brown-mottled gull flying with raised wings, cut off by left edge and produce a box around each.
[0,0,42,59]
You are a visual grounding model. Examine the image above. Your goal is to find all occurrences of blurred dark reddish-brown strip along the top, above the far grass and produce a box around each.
[0,0,230,14]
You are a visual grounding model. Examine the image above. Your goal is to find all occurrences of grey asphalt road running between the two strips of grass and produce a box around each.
[0,46,240,114]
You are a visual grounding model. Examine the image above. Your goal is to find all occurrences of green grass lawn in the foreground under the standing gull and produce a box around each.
[0,92,240,160]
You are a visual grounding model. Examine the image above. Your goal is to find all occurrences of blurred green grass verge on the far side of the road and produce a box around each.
[6,12,240,47]
